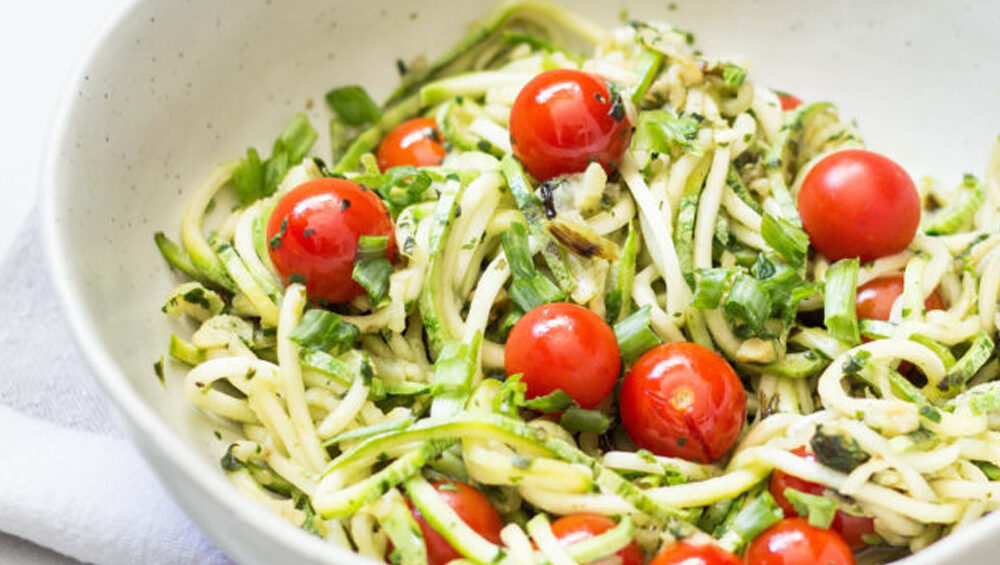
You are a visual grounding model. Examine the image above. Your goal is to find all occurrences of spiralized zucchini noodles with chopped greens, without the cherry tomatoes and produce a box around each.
[156,0,1000,565]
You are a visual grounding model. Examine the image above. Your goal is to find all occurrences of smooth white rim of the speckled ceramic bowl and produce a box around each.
[38,0,1000,565]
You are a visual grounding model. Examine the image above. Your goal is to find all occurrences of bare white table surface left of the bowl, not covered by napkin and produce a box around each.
[0,0,127,565]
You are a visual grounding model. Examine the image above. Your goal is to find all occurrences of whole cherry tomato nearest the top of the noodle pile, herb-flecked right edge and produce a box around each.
[510,69,632,181]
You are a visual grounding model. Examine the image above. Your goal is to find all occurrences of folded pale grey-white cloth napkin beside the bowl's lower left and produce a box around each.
[0,213,231,565]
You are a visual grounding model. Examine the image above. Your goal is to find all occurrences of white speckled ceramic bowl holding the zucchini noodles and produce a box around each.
[43,0,1000,564]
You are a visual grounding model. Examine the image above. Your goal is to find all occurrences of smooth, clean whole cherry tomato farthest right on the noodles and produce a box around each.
[799,149,920,263]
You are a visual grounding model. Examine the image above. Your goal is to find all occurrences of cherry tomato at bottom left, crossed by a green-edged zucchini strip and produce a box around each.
[407,481,503,565]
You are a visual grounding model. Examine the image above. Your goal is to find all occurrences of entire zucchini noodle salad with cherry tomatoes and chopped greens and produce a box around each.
[156,0,1000,565]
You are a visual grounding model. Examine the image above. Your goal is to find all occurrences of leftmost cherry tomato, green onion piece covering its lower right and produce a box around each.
[267,178,396,303]
